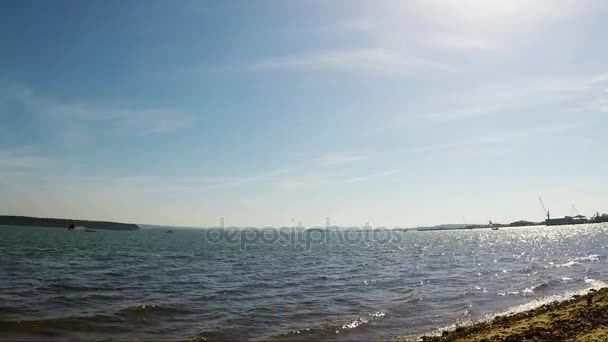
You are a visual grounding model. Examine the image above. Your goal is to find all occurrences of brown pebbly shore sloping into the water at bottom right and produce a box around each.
[422,288,608,342]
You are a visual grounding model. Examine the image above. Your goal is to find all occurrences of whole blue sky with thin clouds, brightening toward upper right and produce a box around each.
[0,0,608,227]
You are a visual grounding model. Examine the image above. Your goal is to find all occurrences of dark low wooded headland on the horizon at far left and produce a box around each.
[0,215,139,231]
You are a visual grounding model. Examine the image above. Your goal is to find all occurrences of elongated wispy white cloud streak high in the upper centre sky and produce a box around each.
[249,49,455,74]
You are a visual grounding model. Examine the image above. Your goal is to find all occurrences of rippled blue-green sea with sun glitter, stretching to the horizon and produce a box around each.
[0,225,608,341]
